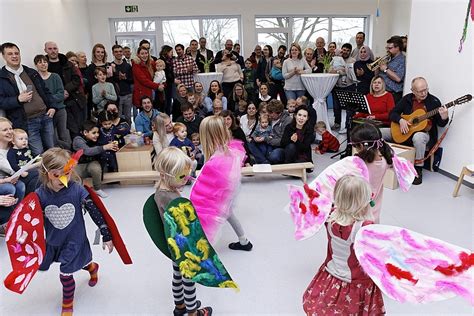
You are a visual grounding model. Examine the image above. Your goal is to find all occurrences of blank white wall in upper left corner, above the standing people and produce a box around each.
[0,0,92,66]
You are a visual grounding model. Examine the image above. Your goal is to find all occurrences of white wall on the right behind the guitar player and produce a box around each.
[405,0,474,183]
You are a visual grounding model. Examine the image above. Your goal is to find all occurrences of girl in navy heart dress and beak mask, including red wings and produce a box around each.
[4,148,131,315]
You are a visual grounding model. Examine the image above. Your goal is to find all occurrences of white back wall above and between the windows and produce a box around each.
[87,0,411,56]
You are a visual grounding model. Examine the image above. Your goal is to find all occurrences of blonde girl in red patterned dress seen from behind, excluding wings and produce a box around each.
[303,175,385,316]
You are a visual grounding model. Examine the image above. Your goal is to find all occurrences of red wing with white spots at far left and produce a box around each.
[4,193,46,294]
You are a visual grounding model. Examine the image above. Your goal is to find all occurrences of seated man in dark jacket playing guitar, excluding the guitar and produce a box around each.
[389,77,449,185]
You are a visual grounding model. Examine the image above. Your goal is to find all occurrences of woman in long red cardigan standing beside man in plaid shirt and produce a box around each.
[132,47,159,109]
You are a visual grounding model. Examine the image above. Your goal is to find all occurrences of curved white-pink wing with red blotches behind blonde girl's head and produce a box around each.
[289,156,369,240]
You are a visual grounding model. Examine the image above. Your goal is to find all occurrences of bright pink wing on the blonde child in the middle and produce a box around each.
[190,142,245,242]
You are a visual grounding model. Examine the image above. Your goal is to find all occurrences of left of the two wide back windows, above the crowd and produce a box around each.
[110,16,243,56]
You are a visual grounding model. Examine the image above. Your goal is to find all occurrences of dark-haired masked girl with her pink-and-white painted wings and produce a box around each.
[289,123,416,239]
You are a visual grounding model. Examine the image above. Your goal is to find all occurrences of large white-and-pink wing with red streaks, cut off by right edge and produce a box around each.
[354,225,474,305]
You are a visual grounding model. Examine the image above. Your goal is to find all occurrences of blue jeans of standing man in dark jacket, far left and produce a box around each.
[28,114,54,156]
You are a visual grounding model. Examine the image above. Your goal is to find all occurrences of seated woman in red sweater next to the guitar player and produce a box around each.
[354,76,395,126]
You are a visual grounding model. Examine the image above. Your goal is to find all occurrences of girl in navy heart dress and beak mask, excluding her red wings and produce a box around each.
[36,148,114,316]
